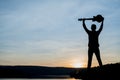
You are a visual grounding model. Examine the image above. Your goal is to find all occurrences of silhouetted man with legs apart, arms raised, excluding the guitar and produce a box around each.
[83,19,104,70]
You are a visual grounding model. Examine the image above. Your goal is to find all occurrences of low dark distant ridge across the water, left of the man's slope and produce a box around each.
[0,66,76,78]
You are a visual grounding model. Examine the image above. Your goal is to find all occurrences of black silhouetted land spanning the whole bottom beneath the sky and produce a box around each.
[0,63,120,80]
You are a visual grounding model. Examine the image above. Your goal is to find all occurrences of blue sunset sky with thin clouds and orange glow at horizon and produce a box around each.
[0,0,120,67]
